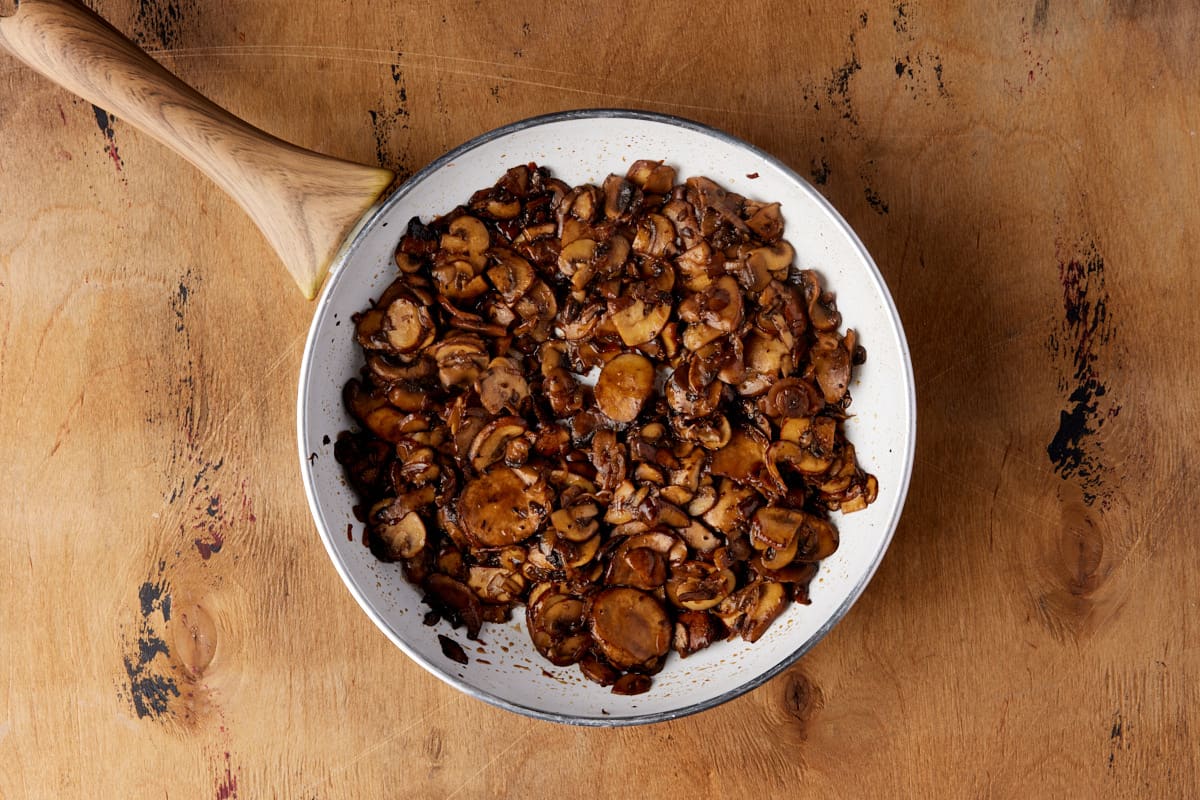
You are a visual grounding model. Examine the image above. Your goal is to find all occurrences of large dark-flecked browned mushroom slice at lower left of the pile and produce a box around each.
[457,465,550,547]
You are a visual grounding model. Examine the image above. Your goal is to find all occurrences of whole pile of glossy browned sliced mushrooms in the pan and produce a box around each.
[335,161,877,693]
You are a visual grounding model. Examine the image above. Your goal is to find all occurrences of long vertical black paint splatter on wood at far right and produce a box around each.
[1046,241,1121,507]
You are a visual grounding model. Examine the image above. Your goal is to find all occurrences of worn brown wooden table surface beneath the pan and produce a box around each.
[0,0,1200,800]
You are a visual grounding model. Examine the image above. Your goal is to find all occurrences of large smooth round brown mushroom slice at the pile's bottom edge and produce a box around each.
[588,587,673,669]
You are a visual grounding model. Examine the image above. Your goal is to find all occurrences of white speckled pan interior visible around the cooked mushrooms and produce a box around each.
[298,110,916,726]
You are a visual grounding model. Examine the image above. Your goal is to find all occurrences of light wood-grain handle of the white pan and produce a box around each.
[0,0,394,300]
